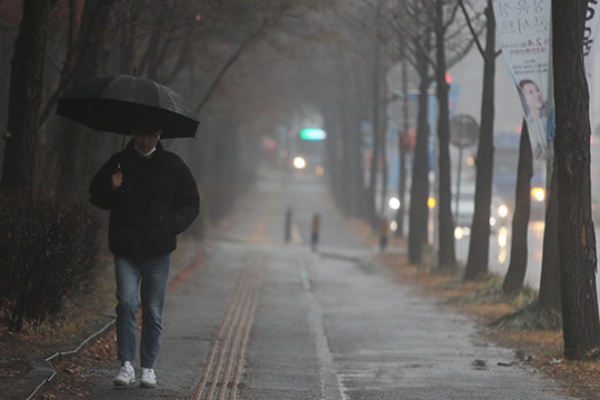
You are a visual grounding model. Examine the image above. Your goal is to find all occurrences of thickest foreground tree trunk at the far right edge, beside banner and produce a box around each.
[552,0,600,359]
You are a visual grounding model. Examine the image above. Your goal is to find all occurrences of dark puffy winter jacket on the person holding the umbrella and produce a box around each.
[90,142,200,259]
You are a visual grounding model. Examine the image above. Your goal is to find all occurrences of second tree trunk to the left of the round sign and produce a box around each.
[408,32,429,264]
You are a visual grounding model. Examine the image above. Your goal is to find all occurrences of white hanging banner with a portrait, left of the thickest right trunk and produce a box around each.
[493,0,553,159]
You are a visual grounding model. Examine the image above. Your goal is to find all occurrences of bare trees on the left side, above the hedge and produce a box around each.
[0,0,342,218]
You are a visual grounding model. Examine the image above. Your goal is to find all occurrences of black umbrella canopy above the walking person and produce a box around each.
[56,75,200,139]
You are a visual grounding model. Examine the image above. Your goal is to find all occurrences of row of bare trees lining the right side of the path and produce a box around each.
[300,0,600,359]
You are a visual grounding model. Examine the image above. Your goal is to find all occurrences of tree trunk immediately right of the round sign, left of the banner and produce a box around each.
[465,0,496,281]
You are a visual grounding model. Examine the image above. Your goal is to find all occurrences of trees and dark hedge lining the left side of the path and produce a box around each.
[0,0,336,330]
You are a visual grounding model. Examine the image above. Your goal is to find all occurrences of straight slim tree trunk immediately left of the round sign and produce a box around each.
[435,0,456,268]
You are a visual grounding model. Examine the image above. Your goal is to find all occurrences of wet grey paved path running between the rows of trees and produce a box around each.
[83,172,568,400]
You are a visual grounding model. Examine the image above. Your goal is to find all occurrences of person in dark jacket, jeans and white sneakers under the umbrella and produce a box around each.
[90,127,200,388]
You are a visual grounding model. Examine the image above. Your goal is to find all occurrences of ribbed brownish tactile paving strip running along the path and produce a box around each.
[191,252,265,400]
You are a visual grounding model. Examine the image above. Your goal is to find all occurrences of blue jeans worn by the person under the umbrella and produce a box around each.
[115,254,171,368]
